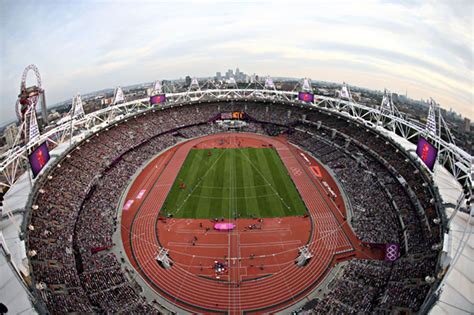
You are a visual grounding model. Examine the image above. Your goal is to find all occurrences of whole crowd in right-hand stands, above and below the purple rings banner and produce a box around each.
[290,113,440,314]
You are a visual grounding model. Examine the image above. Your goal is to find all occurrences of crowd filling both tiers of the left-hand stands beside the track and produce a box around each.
[28,108,217,313]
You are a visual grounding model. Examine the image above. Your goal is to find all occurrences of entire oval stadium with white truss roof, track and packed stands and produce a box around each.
[1,67,472,314]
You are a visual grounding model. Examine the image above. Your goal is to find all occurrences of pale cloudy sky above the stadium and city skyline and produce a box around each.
[0,0,474,125]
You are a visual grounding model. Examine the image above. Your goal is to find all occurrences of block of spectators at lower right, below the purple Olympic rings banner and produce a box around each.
[304,260,432,314]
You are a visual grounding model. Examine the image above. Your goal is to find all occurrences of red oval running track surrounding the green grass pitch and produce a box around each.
[121,133,380,314]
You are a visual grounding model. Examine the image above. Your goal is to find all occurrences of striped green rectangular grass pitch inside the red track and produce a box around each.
[161,148,306,219]
